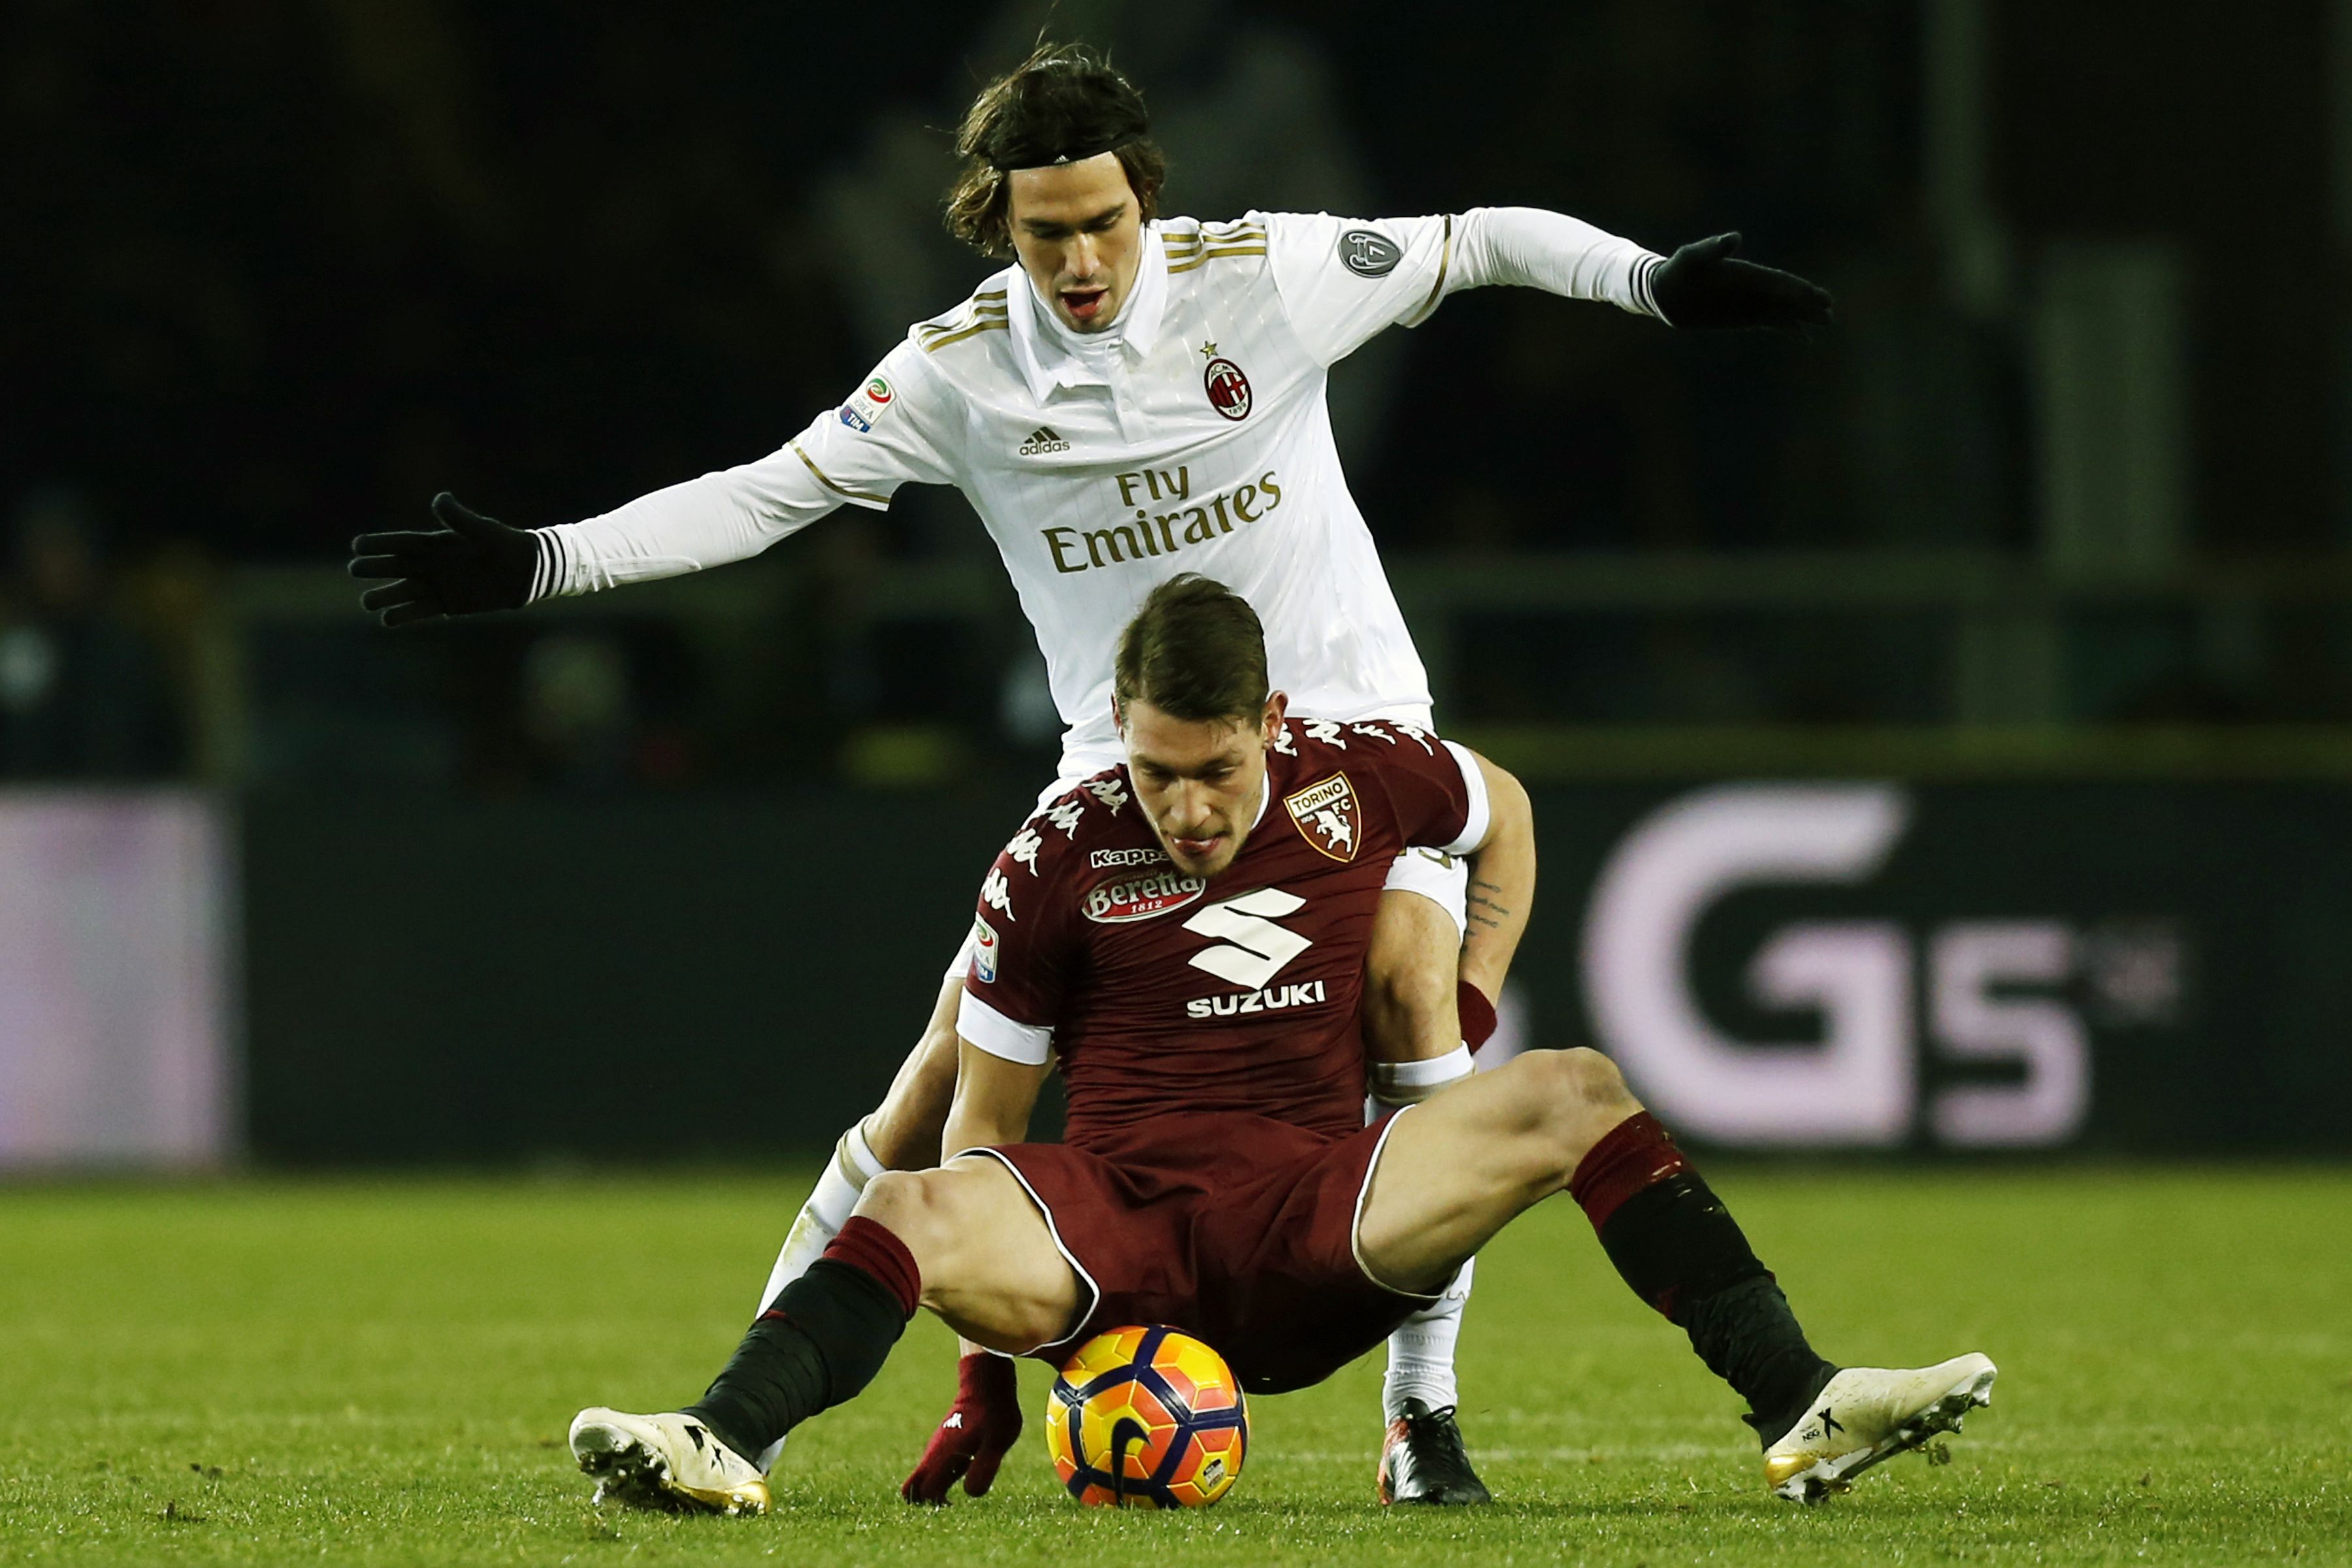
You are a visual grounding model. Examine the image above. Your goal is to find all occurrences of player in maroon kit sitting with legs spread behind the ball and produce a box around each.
[572,576,1995,1512]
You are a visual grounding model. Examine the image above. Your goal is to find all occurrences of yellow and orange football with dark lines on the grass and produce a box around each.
[1044,1328,1249,1509]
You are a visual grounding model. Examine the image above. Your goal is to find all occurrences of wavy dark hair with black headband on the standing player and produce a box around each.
[948,42,1167,256]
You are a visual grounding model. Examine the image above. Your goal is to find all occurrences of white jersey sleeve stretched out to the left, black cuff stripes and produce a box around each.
[534,341,962,597]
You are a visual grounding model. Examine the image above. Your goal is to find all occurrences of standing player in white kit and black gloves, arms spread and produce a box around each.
[353,47,1830,1502]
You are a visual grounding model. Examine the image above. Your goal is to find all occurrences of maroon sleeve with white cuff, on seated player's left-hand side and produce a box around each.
[955,813,1075,1065]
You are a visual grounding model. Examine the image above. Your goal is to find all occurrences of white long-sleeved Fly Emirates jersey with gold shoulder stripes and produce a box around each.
[541,212,1649,776]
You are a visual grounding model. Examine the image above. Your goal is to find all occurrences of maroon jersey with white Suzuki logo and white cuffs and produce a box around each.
[960,719,1486,1152]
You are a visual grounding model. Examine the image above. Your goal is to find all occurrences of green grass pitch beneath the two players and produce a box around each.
[0,1166,2352,1568]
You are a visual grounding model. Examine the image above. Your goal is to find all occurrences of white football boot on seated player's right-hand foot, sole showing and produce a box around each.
[1764,1354,1999,1502]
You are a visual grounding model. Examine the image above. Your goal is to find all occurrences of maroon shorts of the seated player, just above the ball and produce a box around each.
[979,1115,1437,1394]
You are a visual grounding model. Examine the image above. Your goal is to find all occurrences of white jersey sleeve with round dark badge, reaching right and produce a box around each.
[1251,207,1658,365]
